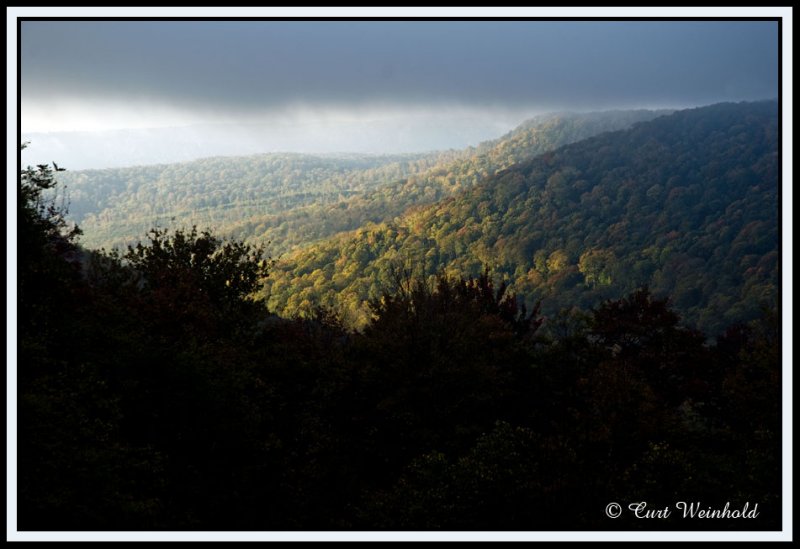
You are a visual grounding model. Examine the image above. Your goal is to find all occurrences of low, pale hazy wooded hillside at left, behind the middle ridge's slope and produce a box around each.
[60,152,455,252]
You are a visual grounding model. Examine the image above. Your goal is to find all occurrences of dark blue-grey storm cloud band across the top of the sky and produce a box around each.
[21,21,778,111]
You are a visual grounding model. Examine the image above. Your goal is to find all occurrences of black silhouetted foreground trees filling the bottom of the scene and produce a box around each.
[17,161,781,530]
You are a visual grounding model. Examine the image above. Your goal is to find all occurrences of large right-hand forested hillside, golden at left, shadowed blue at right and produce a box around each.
[267,101,779,333]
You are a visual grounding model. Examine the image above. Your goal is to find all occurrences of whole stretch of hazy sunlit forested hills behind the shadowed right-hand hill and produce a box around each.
[62,110,666,254]
